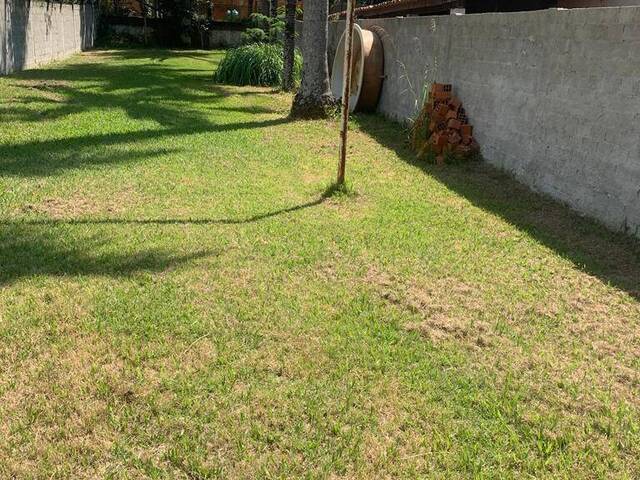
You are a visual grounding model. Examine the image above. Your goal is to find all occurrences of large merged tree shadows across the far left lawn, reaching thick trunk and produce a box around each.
[0,50,289,177]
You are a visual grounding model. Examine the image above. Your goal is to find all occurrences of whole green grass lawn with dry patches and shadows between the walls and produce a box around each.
[0,51,640,479]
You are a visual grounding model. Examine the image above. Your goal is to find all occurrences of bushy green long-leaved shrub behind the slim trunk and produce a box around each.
[213,43,302,87]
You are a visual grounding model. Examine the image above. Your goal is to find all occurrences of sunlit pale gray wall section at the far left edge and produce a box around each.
[0,0,98,75]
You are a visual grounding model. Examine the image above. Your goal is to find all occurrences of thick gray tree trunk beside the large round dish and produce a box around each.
[291,0,336,118]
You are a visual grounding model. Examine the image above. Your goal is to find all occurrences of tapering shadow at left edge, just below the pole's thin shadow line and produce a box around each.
[0,224,219,287]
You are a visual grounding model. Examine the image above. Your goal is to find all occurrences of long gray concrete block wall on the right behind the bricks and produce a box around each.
[329,7,640,236]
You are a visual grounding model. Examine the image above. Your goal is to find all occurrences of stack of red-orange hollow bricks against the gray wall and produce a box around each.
[424,83,480,164]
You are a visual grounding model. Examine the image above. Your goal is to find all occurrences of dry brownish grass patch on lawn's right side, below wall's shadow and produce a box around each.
[363,266,640,414]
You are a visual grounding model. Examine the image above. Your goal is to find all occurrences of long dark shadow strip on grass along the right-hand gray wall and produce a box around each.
[357,115,640,300]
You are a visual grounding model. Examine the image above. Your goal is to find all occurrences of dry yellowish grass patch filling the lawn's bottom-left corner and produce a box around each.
[0,319,229,478]
